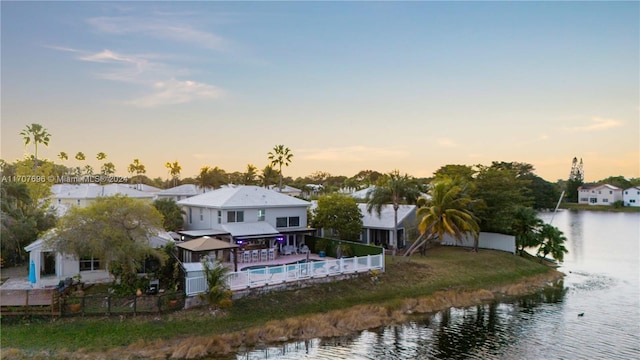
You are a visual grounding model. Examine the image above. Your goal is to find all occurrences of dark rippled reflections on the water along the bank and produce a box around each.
[237,281,566,359]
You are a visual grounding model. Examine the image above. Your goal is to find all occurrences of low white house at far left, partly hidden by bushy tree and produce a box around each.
[24,229,173,288]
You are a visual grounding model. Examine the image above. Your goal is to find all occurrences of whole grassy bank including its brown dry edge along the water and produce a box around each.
[2,247,564,359]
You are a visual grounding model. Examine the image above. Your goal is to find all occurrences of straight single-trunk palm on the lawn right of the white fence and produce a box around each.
[367,170,420,259]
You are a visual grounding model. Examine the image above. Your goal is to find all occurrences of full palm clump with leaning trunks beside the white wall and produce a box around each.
[405,179,480,256]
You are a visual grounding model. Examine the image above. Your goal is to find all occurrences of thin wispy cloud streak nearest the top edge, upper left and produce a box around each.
[87,16,228,50]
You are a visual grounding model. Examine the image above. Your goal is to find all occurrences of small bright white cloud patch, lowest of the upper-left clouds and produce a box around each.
[126,79,224,108]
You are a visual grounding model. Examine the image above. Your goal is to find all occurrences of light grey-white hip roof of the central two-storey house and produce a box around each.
[178,186,311,208]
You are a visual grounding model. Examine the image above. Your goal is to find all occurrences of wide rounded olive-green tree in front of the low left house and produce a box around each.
[47,195,164,283]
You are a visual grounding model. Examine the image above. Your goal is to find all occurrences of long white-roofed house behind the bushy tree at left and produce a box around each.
[51,183,154,216]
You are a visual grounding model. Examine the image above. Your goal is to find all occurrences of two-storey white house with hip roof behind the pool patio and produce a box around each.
[178,185,314,252]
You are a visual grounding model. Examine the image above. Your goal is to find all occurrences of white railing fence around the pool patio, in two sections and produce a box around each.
[185,254,384,296]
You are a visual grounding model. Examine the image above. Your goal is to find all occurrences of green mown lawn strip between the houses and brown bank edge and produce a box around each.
[1,247,553,352]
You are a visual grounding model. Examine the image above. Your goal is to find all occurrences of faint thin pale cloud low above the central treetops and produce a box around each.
[299,145,406,162]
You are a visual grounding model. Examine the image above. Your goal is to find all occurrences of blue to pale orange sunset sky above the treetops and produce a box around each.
[0,1,640,182]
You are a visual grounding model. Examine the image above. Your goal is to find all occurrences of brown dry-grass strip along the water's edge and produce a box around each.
[3,269,565,360]
